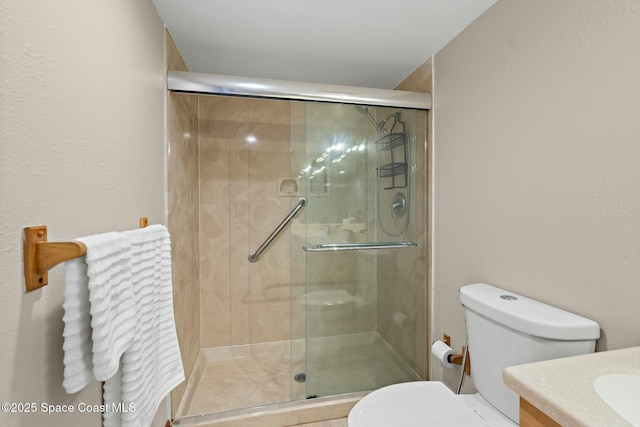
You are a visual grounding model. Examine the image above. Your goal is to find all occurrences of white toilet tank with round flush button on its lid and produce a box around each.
[460,283,600,423]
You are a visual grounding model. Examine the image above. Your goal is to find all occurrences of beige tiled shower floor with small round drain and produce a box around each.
[177,333,420,418]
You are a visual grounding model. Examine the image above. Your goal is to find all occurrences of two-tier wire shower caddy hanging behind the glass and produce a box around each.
[376,132,407,190]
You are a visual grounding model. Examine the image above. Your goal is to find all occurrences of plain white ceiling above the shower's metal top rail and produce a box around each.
[153,0,496,89]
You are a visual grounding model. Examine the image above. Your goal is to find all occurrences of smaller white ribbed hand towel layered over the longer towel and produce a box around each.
[62,232,136,393]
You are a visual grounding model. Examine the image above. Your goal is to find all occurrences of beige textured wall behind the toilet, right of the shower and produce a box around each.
[433,0,640,388]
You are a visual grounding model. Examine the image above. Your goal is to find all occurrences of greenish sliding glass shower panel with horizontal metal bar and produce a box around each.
[299,102,418,398]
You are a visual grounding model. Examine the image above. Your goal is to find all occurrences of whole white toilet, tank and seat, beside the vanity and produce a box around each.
[349,283,600,427]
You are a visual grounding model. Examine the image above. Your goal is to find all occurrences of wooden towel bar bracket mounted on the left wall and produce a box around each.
[23,217,149,292]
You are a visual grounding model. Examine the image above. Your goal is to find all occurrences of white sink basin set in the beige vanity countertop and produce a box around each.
[593,374,640,427]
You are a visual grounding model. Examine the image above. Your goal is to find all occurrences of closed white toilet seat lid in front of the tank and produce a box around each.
[348,381,517,427]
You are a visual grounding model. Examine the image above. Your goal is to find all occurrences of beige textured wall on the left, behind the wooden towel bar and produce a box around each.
[0,0,165,427]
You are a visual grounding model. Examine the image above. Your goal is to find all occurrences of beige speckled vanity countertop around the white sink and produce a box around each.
[503,347,640,427]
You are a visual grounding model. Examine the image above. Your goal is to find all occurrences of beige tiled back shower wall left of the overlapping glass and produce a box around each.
[199,96,291,348]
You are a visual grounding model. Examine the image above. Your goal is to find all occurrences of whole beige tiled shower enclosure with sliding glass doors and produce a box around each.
[168,73,429,425]
